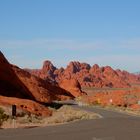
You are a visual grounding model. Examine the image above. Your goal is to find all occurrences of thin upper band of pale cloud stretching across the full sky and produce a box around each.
[0,38,140,51]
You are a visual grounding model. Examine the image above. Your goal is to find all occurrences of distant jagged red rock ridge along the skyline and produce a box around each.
[26,61,140,88]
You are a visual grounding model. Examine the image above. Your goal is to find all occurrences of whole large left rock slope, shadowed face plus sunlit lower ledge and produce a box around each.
[0,52,74,115]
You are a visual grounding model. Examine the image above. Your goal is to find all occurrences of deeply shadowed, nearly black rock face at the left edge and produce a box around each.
[0,52,34,99]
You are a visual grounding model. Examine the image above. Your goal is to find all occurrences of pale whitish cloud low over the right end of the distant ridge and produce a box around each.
[81,55,140,72]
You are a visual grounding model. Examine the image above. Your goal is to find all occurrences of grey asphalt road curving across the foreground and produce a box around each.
[0,105,140,140]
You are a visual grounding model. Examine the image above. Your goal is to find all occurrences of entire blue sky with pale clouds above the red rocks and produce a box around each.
[0,0,140,72]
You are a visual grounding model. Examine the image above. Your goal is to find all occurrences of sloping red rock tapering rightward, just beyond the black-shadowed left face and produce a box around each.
[12,66,73,103]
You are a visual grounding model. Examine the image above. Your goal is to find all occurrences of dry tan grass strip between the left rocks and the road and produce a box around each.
[2,105,101,128]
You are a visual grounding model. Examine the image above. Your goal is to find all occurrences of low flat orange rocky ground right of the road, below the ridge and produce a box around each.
[81,87,140,111]
